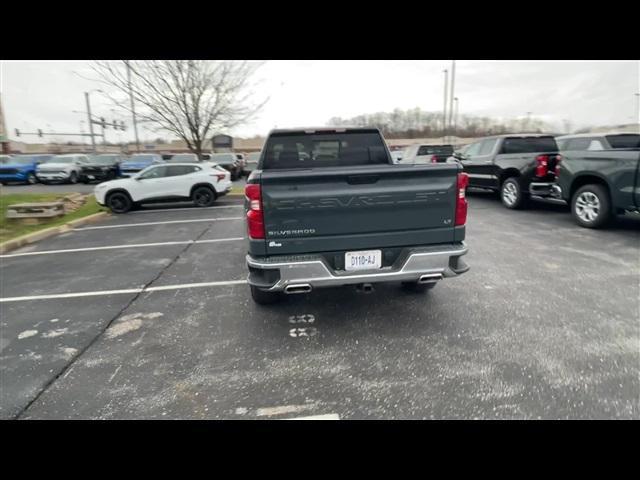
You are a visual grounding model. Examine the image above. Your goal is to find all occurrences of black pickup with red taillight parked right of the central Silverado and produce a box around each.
[447,134,560,209]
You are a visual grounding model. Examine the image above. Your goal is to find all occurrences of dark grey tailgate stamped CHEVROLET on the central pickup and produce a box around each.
[260,164,459,255]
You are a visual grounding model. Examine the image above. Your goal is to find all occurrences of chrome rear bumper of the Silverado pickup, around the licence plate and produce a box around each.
[246,242,469,293]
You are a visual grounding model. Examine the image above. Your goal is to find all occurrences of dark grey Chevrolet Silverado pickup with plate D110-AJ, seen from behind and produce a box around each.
[245,128,469,304]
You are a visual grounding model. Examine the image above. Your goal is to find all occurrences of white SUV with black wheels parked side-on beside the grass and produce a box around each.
[94,163,231,213]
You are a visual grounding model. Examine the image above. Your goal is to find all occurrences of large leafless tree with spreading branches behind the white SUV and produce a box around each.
[93,60,268,158]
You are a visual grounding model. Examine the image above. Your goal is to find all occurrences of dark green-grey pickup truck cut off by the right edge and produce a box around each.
[554,147,640,228]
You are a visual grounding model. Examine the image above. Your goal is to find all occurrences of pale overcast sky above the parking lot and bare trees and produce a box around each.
[0,60,640,142]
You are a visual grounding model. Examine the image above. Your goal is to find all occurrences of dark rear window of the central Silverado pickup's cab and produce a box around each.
[262,132,392,170]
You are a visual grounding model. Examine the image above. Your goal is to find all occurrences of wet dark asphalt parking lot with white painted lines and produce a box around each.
[0,189,640,419]
